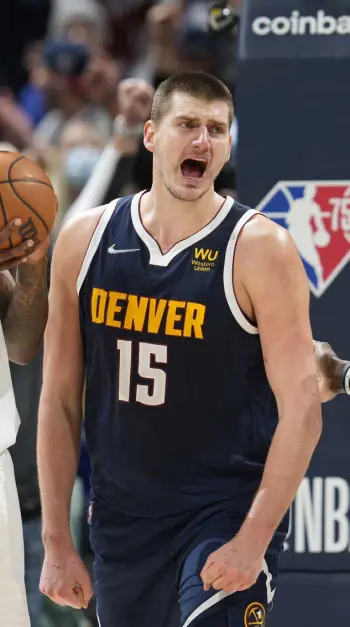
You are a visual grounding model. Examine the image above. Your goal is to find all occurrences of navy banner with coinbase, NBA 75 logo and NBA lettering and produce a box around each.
[237,0,350,627]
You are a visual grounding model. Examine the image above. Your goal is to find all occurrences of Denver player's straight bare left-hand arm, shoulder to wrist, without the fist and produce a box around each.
[37,207,104,549]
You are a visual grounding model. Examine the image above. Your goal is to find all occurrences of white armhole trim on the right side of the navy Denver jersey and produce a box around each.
[224,209,259,335]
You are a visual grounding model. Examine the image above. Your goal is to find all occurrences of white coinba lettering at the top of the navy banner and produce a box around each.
[252,10,350,37]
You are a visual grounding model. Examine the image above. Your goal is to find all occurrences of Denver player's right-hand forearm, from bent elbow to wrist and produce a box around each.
[240,394,322,553]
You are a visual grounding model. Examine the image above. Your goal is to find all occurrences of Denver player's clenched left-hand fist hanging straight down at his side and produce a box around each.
[39,545,93,609]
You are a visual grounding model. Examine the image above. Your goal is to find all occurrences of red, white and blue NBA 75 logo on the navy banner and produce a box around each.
[257,181,350,296]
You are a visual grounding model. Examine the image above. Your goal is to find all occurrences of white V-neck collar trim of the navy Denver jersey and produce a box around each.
[131,192,234,268]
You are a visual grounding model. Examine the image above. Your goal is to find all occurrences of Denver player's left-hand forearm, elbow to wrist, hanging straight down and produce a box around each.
[37,398,82,546]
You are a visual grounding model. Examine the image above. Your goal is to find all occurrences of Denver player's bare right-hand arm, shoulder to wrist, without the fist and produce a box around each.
[235,216,322,554]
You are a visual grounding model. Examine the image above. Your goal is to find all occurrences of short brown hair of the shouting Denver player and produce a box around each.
[151,71,233,126]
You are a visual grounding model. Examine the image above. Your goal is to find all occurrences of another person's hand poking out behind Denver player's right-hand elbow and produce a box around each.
[314,341,346,403]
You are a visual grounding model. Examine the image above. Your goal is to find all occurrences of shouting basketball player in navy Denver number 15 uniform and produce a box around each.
[38,72,348,627]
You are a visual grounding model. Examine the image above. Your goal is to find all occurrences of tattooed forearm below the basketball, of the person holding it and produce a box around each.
[2,259,48,364]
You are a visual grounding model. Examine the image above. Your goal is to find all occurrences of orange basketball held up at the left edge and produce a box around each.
[0,151,57,250]
